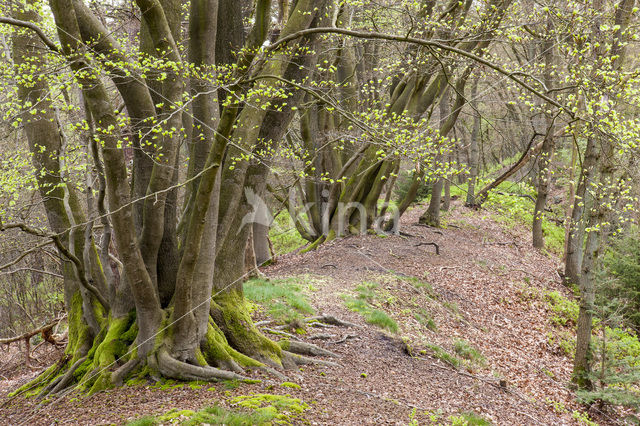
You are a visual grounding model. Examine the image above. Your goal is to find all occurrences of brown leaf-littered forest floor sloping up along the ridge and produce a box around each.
[0,203,617,425]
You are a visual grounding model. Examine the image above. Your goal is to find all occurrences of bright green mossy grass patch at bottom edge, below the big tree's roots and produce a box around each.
[127,394,309,426]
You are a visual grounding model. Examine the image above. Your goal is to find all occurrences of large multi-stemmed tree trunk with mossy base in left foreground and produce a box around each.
[3,0,331,394]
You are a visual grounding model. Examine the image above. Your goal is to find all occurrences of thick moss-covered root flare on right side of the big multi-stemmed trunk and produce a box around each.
[211,290,286,368]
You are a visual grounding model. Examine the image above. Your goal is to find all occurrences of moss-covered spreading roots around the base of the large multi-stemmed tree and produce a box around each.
[12,293,344,398]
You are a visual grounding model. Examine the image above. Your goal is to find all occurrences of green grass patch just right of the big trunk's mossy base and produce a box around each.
[244,276,314,323]
